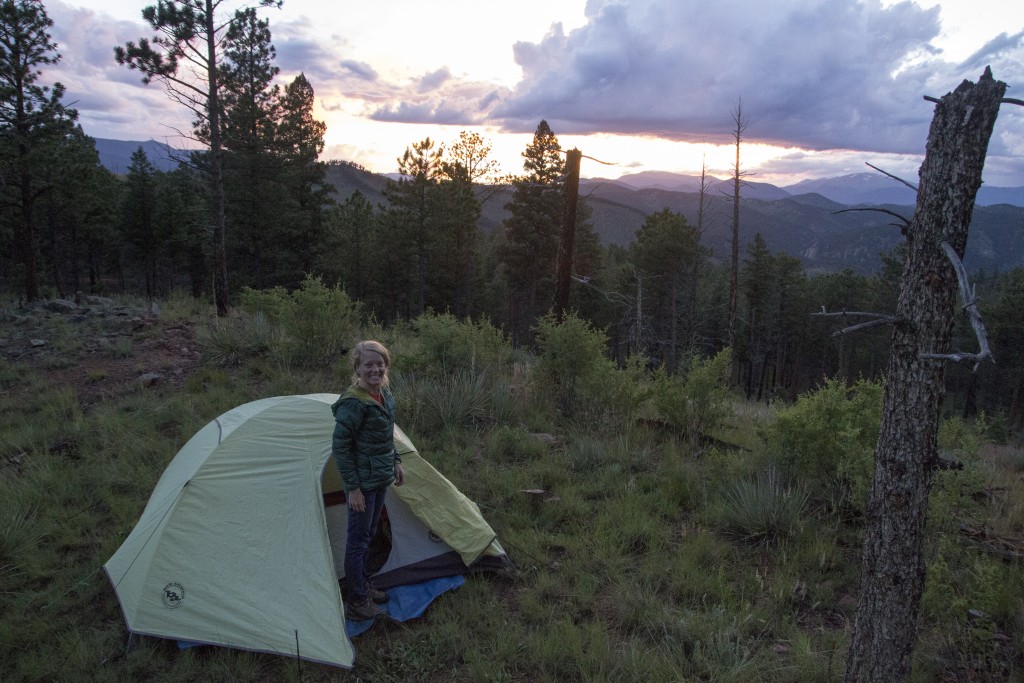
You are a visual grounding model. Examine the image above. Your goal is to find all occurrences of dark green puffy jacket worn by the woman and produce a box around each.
[331,384,398,493]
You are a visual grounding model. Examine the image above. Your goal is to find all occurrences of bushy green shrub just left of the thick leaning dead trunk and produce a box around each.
[762,380,883,510]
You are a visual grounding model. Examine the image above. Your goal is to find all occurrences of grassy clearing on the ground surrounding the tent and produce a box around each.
[0,299,1024,682]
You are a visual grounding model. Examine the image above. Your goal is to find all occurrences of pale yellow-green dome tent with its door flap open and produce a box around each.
[103,393,508,667]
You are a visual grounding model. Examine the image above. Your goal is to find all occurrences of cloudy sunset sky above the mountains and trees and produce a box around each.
[42,0,1024,186]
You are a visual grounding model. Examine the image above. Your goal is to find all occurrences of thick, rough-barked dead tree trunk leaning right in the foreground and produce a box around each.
[846,69,1007,683]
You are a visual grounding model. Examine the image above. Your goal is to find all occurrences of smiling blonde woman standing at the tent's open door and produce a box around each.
[331,341,406,621]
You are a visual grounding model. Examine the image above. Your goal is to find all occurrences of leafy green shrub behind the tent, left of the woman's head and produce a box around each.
[242,275,361,368]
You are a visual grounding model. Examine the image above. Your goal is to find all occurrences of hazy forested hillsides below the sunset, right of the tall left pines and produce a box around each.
[328,164,1024,273]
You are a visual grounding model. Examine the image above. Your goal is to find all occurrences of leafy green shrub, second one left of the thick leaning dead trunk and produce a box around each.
[651,348,732,444]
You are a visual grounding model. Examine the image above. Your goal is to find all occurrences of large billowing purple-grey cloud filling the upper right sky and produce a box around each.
[490,0,1024,154]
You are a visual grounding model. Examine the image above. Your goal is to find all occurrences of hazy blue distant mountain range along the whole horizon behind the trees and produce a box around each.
[96,139,1024,272]
